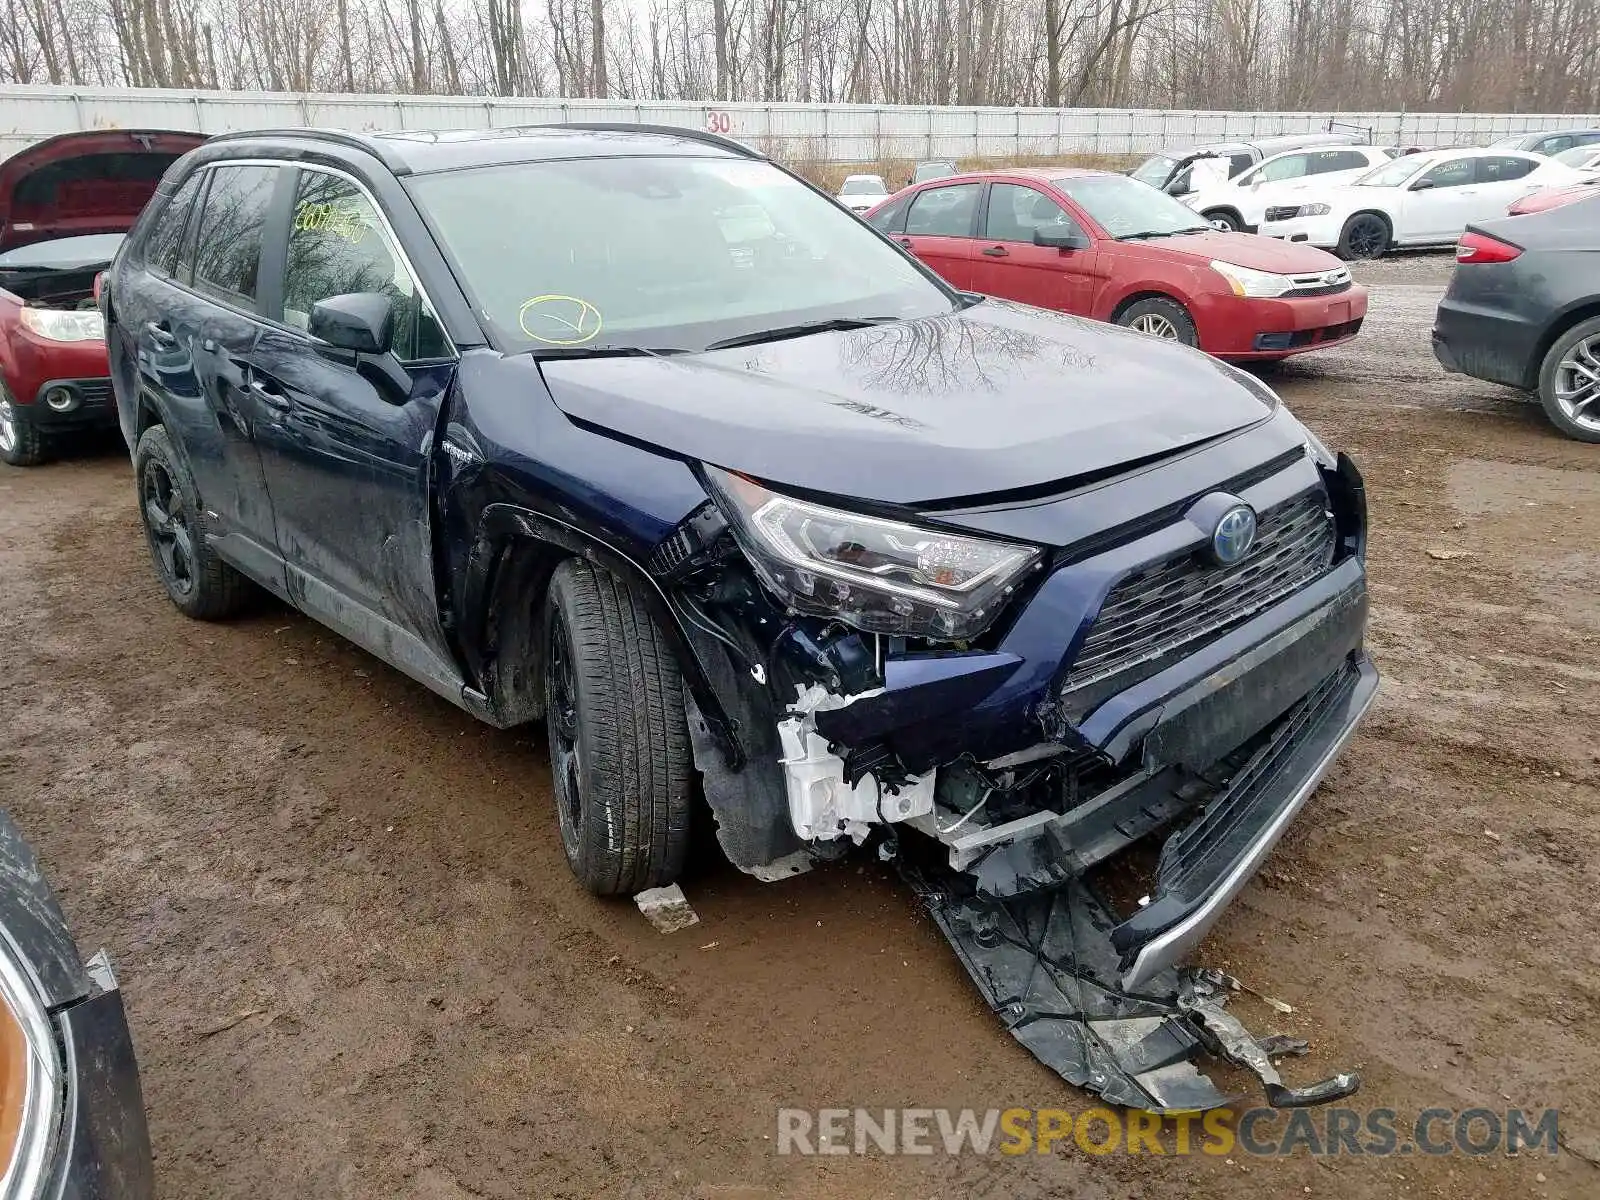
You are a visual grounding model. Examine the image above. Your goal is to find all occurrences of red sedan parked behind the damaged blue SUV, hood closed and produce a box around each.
[867,168,1366,358]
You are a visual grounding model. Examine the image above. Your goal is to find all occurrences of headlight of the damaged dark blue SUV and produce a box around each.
[706,467,1042,642]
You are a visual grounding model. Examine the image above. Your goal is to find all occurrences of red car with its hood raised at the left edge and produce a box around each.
[0,130,205,467]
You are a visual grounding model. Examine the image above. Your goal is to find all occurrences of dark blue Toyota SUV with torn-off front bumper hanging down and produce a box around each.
[101,126,1378,1109]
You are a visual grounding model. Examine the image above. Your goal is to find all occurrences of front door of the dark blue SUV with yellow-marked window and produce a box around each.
[250,166,459,694]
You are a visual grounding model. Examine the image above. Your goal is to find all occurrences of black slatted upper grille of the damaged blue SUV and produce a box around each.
[1064,488,1336,691]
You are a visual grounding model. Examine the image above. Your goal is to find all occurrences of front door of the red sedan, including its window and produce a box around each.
[971,182,1096,317]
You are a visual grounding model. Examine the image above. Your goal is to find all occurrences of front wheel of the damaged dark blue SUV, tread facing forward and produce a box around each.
[544,560,693,896]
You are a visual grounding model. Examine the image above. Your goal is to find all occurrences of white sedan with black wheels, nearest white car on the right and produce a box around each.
[1261,150,1586,259]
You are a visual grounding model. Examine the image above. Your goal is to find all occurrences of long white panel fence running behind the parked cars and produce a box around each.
[0,86,1600,163]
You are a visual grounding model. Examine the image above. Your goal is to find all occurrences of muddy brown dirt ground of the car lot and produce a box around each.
[0,256,1600,1200]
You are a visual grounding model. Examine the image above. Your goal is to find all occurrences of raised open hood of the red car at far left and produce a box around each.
[0,130,205,251]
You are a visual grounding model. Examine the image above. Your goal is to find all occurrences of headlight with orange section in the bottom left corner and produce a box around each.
[0,930,61,1197]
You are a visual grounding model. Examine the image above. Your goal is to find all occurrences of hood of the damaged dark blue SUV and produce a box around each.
[541,301,1269,504]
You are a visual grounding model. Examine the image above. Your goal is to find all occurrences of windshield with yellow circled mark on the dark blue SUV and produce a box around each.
[410,157,957,354]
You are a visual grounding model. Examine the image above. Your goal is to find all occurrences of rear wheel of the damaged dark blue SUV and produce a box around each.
[133,426,250,621]
